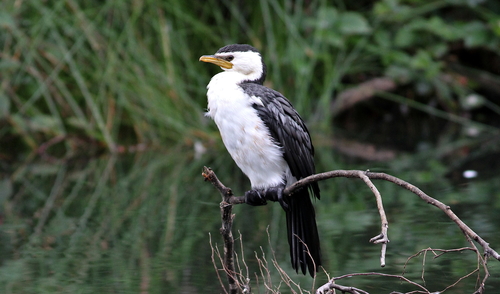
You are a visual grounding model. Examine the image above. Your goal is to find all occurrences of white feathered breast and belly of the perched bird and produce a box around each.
[206,72,290,189]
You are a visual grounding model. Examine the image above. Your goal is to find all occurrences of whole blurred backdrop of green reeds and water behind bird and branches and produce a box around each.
[0,0,500,293]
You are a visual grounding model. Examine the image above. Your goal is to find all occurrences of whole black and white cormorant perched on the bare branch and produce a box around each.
[200,44,321,276]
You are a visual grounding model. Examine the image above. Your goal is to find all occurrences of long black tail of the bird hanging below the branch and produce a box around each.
[286,188,321,277]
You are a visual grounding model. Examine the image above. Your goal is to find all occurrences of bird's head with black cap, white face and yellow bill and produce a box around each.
[200,44,266,84]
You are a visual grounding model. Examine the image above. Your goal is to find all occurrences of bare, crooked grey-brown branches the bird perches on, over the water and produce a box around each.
[203,167,500,294]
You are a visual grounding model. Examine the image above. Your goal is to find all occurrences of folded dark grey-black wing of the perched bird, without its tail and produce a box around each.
[240,83,320,199]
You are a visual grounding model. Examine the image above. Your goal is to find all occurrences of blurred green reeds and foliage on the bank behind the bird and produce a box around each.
[0,0,499,156]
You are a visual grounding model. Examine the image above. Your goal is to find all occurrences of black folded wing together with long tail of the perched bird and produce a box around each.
[240,83,321,276]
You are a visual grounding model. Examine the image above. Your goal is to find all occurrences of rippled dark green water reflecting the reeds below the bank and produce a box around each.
[0,148,500,293]
